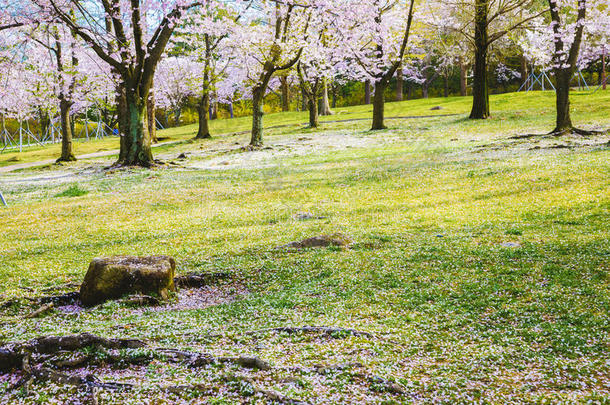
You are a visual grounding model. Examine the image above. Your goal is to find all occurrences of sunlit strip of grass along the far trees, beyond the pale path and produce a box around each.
[0,91,610,167]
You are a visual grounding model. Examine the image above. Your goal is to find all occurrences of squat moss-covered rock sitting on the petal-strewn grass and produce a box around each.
[80,256,176,306]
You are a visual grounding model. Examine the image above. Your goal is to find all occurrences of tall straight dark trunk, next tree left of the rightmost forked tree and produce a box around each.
[470,0,489,119]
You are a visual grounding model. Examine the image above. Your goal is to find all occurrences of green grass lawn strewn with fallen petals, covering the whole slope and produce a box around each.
[0,92,610,404]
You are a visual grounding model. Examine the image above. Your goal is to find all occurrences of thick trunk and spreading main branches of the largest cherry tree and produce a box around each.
[26,0,201,167]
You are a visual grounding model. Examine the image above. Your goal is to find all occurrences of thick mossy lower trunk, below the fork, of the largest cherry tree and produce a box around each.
[117,87,154,167]
